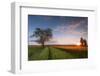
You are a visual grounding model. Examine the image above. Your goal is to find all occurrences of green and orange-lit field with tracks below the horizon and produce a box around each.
[28,45,88,61]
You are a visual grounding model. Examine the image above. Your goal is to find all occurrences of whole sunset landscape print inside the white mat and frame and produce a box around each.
[27,15,88,61]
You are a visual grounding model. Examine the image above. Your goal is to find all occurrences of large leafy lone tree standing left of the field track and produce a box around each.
[32,28,52,47]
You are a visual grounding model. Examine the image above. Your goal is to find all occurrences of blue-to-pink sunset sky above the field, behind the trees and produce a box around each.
[28,15,88,45]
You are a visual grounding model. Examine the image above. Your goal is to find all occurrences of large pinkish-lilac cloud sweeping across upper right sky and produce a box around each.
[53,20,87,36]
